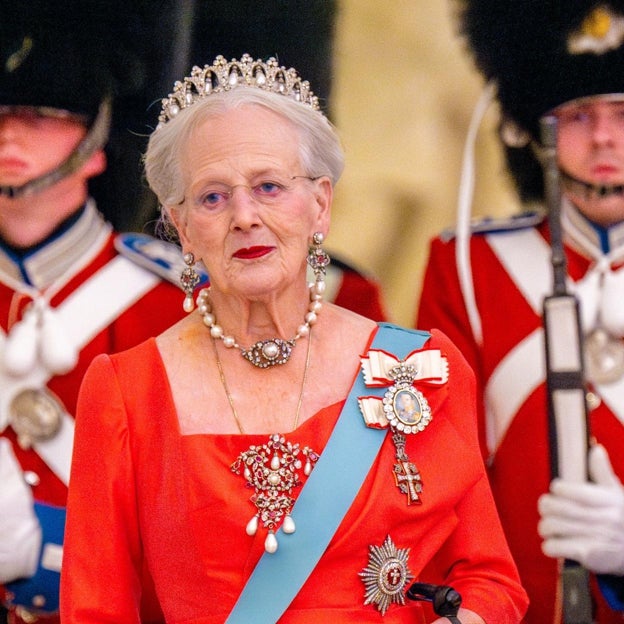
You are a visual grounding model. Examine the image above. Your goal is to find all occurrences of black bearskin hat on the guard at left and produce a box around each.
[0,0,112,117]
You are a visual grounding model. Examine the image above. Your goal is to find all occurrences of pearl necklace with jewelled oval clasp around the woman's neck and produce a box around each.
[197,280,325,368]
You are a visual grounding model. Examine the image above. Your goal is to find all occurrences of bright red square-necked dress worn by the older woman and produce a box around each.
[61,334,526,624]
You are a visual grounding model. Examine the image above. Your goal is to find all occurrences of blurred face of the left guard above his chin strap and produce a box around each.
[0,107,86,186]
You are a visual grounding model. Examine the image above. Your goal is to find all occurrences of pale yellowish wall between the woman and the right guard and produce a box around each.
[328,0,519,325]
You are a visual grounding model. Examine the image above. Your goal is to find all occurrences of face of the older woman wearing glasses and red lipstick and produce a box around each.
[170,105,332,299]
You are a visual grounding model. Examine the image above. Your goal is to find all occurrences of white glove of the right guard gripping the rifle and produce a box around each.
[537,444,624,575]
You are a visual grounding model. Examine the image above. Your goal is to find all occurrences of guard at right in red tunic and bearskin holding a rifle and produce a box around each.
[417,0,624,624]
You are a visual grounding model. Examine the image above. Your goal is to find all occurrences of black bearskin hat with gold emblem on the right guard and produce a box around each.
[458,0,624,200]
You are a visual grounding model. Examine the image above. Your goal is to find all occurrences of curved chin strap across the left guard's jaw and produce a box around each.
[0,98,112,198]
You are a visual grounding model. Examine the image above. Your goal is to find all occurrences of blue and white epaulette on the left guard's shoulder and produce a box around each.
[115,232,208,286]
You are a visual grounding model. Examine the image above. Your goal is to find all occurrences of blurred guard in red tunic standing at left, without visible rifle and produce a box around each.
[0,2,193,624]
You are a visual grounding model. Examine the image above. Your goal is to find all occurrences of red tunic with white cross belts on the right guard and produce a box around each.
[417,204,624,624]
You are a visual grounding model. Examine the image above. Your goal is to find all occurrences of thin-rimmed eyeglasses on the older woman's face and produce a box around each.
[188,174,322,211]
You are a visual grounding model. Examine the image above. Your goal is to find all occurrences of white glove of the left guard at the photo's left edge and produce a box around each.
[0,438,41,583]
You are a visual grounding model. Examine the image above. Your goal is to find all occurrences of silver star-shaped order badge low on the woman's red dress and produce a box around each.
[359,535,414,615]
